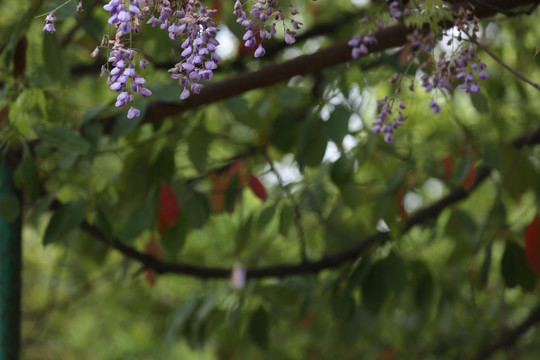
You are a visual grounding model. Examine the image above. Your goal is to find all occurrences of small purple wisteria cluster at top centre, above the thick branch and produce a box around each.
[233,0,312,57]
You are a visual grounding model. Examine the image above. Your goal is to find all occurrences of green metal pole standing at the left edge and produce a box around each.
[0,158,22,360]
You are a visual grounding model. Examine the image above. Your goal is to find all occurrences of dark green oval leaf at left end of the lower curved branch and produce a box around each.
[43,198,86,246]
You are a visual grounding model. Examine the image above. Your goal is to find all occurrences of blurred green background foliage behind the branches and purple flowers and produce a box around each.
[0,0,540,360]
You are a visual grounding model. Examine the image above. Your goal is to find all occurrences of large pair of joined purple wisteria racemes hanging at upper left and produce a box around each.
[43,0,221,118]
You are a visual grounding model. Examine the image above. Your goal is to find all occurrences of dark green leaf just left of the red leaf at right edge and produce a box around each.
[501,241,536,291]
